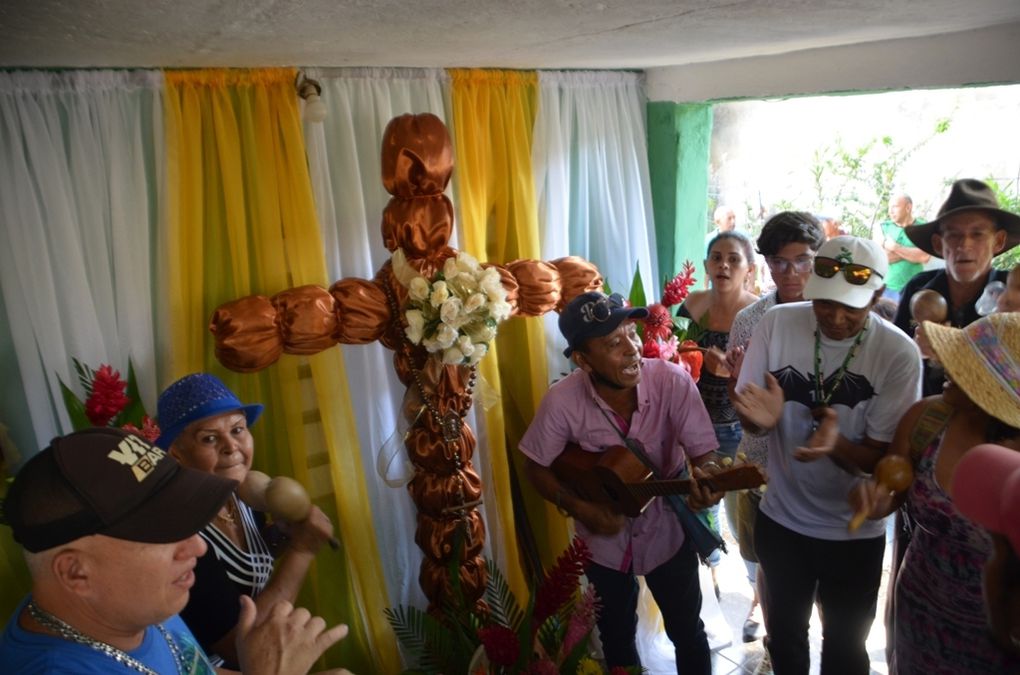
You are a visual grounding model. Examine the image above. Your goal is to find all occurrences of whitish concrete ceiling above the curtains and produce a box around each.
[0,0,1020,69]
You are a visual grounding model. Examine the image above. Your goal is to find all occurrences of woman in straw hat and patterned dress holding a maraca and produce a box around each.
[850,313,1020,675]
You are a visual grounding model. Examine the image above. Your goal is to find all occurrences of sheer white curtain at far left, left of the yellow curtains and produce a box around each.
[0,71,163,456]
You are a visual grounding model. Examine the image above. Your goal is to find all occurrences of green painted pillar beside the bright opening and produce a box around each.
[648,101,712,280]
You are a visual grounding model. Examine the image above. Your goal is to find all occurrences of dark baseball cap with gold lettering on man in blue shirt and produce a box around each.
[3,427,238,553]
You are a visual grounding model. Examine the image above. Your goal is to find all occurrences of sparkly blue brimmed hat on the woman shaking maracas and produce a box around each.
[156,372,263,450]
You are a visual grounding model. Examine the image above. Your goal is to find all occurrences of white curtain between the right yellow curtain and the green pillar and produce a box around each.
[532,71,660,377]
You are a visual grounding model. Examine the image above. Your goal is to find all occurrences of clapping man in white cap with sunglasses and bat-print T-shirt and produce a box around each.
[732,237,921,675]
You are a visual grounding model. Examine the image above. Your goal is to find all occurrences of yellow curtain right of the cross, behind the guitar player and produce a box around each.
[450,70,569,596]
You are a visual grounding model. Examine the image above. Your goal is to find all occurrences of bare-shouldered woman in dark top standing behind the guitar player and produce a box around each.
[677,230,758,596]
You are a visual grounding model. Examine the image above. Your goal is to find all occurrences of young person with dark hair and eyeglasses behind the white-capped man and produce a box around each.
[726,211,825,642]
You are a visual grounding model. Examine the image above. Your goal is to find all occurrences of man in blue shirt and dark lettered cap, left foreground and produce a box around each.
[0,427,347,675]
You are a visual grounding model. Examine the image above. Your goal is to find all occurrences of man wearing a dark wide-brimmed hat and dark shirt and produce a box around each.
[895,178,1020,396]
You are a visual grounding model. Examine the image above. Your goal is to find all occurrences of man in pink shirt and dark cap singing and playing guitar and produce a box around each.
[520,292,722,674]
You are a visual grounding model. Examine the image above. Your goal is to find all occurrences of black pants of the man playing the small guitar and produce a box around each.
[588,539,712,675]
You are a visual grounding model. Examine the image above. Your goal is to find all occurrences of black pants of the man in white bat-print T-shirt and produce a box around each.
[755,511,885,675]
